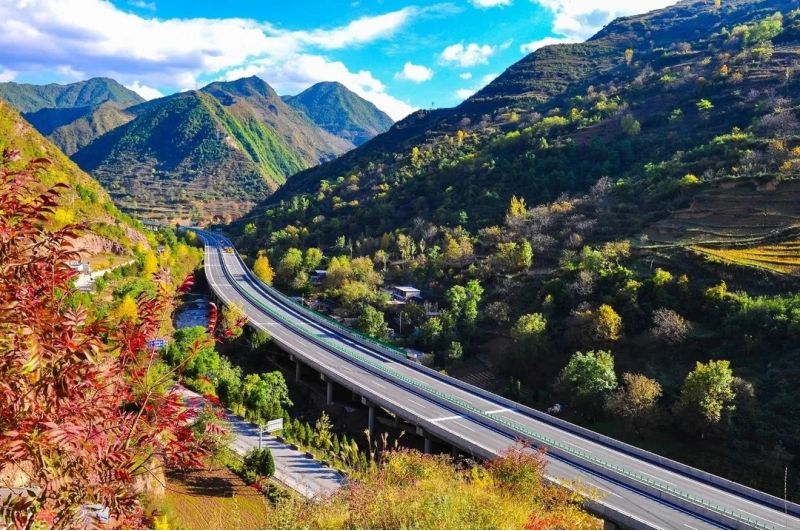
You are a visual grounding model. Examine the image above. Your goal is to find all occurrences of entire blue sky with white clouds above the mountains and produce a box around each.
[0,0,675,119]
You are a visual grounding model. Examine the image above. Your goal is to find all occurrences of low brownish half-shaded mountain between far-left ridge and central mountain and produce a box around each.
[23,102,134,156]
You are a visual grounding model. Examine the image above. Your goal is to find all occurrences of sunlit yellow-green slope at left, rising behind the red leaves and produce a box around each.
[0,99,147,258]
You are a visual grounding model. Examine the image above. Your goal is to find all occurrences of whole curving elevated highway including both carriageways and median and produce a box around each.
[198,231,800,530]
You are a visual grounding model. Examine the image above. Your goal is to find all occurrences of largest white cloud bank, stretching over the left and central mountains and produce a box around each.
[0,0,424,117]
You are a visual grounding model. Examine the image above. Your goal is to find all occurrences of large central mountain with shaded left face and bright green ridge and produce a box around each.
[73,77,353,219]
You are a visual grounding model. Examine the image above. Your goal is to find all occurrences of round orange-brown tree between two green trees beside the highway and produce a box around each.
[606,373,662,435]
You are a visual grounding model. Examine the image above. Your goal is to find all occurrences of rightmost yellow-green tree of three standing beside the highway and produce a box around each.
[678,360,736,431]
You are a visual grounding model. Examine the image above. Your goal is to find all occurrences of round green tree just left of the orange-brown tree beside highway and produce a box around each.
[556,351,617,418]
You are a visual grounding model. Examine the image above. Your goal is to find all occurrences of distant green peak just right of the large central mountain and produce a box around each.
[283,82,394,146]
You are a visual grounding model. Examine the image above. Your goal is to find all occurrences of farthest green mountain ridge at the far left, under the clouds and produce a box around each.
[0,77,144,114]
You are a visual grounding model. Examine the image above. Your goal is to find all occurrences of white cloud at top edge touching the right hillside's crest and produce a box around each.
[531,0,677,40]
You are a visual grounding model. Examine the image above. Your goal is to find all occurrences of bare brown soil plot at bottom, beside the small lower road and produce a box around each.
[165,467,268,529]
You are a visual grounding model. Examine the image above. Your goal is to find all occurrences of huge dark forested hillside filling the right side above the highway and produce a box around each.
[231,0,800,495]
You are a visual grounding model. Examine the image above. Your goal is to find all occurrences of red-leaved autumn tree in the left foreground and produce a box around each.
[0,149,219,529]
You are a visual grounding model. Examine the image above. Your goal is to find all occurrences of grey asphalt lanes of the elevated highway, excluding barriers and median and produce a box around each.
[197,234,800,529]
